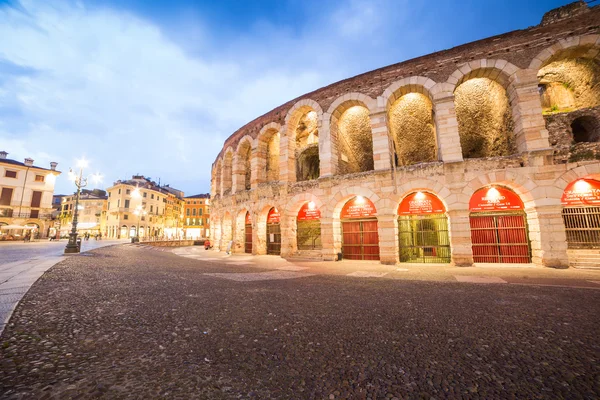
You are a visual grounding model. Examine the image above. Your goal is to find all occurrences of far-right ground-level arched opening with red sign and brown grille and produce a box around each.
[561,179,600,249]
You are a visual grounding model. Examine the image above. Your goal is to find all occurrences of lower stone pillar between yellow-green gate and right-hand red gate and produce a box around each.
[447,209,473,267]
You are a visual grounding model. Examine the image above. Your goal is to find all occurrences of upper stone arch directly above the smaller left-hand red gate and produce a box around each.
[327,93,377,175]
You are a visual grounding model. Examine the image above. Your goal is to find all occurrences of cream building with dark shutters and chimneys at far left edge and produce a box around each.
[0,151,60,239]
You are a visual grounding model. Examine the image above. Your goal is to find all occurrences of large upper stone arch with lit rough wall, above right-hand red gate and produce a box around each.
[447,60,519,158]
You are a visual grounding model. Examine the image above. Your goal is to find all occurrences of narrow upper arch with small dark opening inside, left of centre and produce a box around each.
[279,99,323,182]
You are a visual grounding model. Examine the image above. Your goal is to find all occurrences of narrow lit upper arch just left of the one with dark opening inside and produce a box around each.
[253,122,281,183]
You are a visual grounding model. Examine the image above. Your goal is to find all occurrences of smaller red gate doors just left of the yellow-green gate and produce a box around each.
[342,219,379,260]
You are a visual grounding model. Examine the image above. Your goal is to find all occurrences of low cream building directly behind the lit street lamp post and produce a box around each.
[59,189,108,237]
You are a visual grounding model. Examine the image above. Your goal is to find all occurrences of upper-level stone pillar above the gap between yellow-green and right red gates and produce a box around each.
[433,93,463,162]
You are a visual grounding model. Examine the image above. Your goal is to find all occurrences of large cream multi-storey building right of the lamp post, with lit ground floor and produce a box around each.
[105,175,183,239]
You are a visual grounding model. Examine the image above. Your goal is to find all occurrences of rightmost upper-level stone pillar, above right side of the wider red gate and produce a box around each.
[508,69,550,153]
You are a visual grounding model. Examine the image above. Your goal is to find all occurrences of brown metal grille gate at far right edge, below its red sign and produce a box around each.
[562,207,600,249]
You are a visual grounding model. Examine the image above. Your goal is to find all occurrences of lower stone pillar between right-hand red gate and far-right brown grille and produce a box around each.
[526,205,569,268]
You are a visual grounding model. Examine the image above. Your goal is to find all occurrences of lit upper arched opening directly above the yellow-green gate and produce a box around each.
[388,92,437,166]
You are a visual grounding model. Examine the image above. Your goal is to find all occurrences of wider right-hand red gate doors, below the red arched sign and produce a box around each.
[470,212,531,263]
